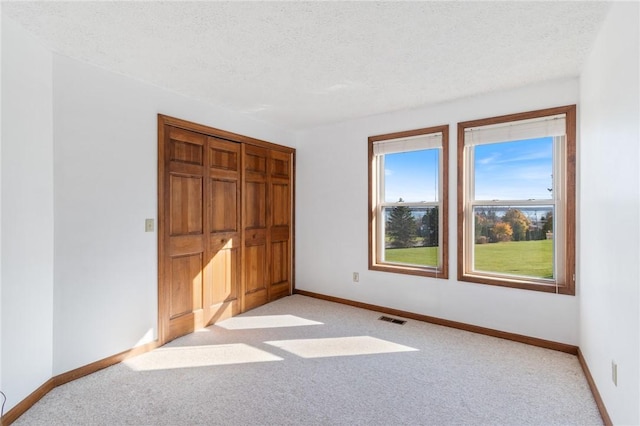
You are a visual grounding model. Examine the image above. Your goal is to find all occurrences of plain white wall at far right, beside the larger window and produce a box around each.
[578,2,640,425]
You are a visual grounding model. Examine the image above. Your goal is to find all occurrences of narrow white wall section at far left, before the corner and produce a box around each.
[0,16,54,409]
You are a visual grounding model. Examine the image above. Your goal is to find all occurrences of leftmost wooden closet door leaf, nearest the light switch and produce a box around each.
[159,126,206,340]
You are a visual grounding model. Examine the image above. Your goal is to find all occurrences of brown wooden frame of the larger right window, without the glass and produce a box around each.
[457,105,576,295]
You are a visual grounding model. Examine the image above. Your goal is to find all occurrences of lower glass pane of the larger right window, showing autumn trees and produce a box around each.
[473,206,554,279]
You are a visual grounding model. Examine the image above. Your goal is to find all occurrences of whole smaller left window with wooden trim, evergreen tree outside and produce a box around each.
[369,126,449,278]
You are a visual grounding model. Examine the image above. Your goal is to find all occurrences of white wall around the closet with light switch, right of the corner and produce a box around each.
[53,55,293,374]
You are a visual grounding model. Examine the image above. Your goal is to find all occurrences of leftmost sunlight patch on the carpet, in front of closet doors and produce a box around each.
[123,343,282,371]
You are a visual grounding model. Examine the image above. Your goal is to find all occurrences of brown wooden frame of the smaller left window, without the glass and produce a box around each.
[368,125,449,279]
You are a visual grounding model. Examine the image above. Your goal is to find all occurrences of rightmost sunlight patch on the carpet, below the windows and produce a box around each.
[265,336,418,358]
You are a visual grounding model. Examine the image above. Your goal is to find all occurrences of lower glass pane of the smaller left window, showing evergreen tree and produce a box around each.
[382,206,439,267]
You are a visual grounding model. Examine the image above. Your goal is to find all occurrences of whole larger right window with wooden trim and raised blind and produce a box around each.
[458,105,576,295]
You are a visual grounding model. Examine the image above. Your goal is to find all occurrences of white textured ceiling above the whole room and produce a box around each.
[2,1,609,129]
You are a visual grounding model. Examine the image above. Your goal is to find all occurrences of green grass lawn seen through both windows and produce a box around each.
[385,240,553,278]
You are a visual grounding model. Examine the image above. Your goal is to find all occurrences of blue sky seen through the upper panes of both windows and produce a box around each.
[385,137,553,202]
